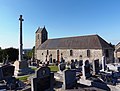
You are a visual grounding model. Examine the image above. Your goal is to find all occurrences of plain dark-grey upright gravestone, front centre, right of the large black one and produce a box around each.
[63,69,77,90]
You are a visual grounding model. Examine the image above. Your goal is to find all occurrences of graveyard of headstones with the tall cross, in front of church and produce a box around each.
[0,15,120,91]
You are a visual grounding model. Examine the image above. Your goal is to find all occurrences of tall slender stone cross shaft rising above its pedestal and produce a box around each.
[19,15,24,61]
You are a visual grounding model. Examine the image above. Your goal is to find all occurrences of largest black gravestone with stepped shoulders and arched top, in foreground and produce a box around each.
[31,67,54,91]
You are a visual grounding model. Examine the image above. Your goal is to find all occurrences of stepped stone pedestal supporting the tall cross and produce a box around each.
[13,61,32,76]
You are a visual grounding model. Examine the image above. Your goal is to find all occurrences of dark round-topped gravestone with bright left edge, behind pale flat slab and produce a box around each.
[82,60,91,79]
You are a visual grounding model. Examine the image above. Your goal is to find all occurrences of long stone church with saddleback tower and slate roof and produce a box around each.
[35,27,114,63]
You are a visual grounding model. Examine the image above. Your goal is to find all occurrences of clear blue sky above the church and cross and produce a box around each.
[0,0,120,48]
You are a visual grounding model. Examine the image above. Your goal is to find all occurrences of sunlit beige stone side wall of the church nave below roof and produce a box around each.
[37,49,103,62]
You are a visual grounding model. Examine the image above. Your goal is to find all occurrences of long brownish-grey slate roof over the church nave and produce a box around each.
[38,35,113,50]
